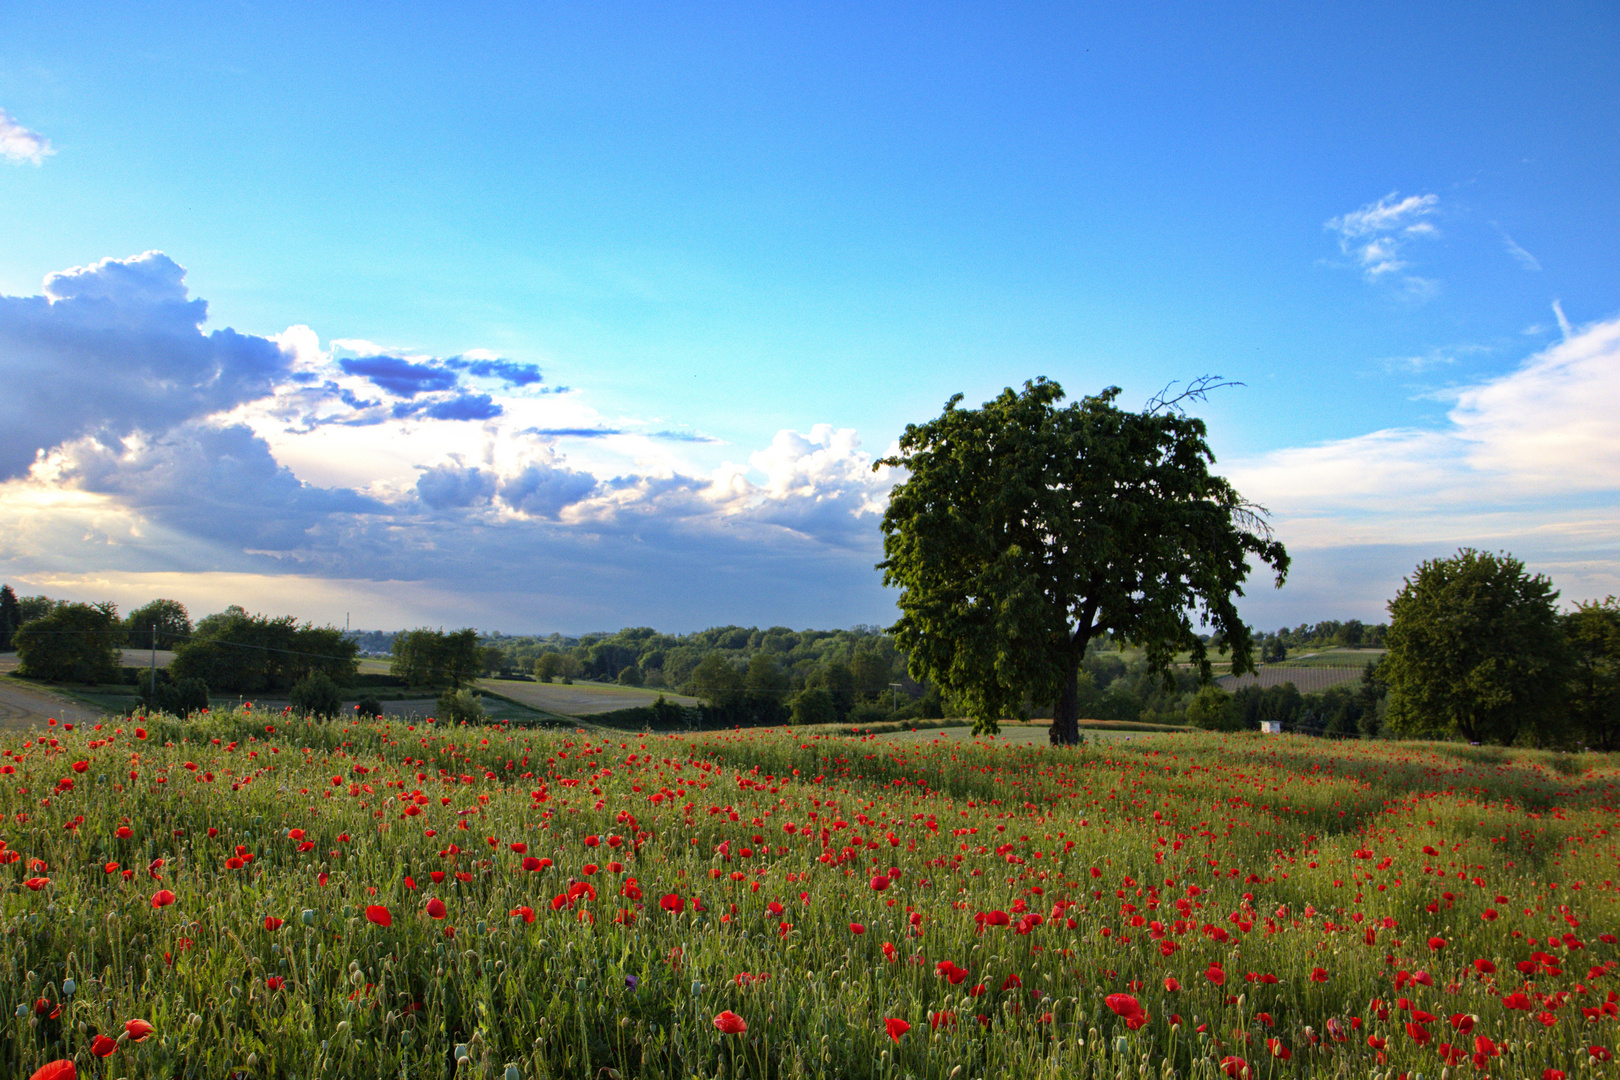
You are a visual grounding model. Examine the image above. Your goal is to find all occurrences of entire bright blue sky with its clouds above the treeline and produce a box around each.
[0,3,1620,631]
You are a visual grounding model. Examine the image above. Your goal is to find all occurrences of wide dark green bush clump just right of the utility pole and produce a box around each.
[168,606,360,695]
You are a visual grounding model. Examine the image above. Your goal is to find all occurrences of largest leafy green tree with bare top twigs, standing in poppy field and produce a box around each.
[878,379,1288,745]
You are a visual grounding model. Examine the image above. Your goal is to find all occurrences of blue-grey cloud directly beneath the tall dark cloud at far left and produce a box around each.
[68,424,387,551]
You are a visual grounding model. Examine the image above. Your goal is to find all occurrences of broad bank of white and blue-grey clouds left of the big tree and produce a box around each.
[0,253,893,623]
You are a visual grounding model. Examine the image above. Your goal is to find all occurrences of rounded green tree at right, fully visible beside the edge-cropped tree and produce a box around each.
[1379,547,1568,745]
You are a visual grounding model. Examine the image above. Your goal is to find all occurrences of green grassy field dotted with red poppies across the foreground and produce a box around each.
[0,708,1620,1080]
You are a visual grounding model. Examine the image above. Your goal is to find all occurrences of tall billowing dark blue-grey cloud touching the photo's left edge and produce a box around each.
[0,251,292,479]
